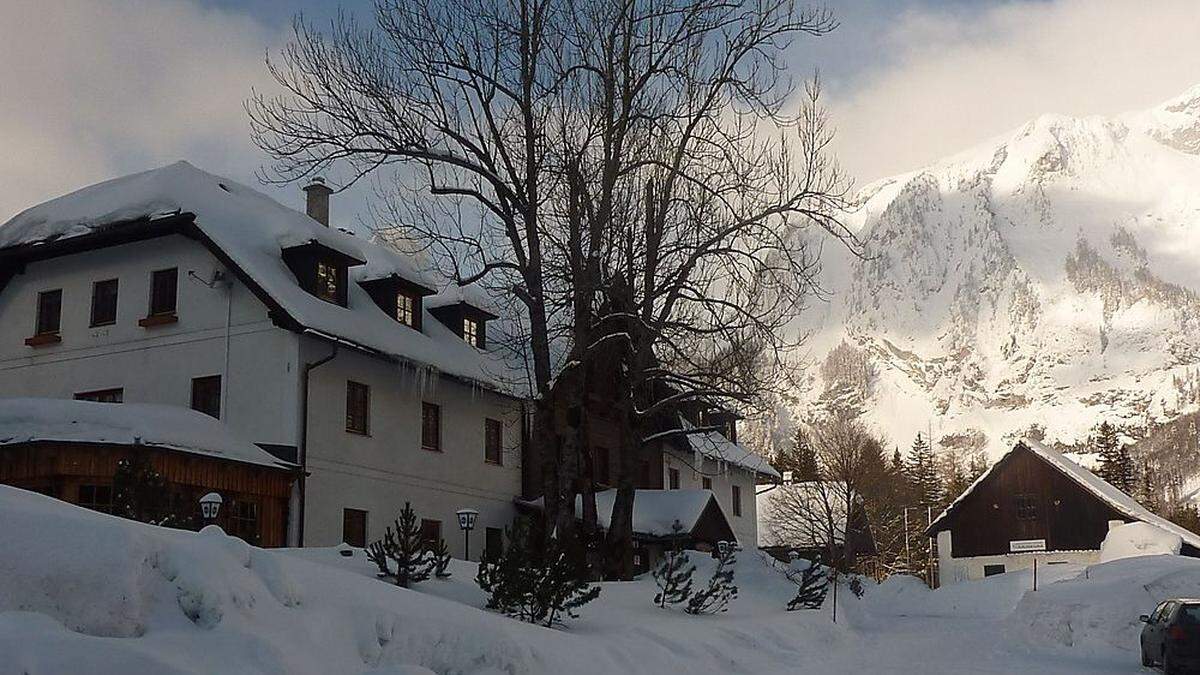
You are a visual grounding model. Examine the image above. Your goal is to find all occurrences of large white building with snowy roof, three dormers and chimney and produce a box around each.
[0,162,522,557]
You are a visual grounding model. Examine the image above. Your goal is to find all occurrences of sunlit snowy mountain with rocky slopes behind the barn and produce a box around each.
[791,86,1200,458]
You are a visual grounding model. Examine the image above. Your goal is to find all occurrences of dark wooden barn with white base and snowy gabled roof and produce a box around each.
[926,441,1200,584]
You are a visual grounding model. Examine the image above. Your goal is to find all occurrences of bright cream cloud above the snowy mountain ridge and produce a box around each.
[821,0,1200,185]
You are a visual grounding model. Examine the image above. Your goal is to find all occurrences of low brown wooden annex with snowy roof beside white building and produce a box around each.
[0,399,298,546]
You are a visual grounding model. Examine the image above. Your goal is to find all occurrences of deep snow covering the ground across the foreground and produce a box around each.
[0,486,1180,675]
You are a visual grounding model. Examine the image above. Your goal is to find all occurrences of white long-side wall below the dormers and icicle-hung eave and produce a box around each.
[302,339,521,560]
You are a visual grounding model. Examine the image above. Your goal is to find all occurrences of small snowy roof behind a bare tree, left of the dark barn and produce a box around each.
[755,480,847,549]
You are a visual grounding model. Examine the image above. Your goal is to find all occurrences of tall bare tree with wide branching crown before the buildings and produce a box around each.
[247,0,853,578]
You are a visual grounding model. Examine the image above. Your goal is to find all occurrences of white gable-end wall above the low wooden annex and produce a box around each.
[0,235,299,444]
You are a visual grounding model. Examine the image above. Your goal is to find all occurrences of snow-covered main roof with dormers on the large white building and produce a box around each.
[0,162,525,390]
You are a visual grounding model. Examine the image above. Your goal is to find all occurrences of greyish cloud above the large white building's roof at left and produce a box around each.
[0,0,284,222]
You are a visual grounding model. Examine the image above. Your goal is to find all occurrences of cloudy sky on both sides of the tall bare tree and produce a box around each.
[0,0,1200,225]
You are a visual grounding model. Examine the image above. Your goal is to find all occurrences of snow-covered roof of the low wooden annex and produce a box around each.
[0,399,293,467]
